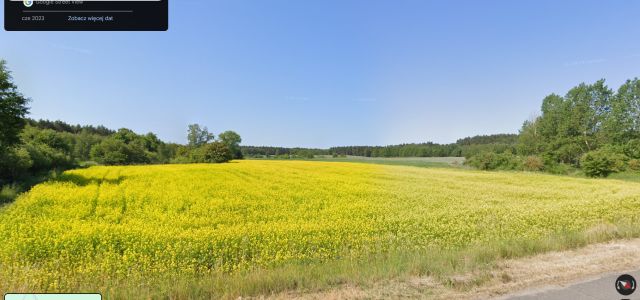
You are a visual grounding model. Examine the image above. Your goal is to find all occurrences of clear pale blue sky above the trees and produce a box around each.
[0,0,640,147]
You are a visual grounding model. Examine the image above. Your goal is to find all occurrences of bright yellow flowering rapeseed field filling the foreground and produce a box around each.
[0,158,640,298]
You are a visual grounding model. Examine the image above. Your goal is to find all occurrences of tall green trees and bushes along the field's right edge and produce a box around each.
[467,78,640,177]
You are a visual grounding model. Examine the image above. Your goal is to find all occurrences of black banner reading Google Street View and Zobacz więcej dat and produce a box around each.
[4,0,169,31]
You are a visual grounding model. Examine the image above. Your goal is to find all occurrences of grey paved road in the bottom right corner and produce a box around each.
[504,270,640,300]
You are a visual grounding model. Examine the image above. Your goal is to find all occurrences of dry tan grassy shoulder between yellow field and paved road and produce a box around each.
[271,239,640,299]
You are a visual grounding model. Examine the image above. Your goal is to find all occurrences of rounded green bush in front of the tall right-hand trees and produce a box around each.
[580,148,627,177]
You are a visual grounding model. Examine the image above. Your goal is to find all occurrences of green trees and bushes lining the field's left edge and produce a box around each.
[0,60,242,185]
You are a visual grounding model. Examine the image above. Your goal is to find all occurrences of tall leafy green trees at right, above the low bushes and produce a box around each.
[518,79,640,170]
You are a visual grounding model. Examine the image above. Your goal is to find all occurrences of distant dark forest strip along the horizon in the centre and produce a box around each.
[242,134,518,158]
